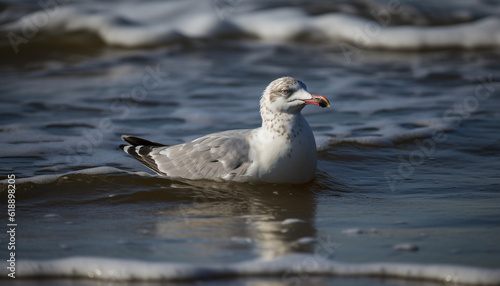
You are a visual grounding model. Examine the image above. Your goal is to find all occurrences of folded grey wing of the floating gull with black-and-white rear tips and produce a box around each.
[124,130,252,180]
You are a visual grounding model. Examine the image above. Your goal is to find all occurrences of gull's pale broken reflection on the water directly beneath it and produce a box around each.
[155,171,346,259]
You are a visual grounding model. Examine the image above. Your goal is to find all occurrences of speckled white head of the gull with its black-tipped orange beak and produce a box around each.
[261,76,330,114]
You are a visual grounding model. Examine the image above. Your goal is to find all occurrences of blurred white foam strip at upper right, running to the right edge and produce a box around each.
[313,14,500,50]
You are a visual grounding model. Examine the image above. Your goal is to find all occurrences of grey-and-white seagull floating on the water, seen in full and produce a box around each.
[120,76,330,184]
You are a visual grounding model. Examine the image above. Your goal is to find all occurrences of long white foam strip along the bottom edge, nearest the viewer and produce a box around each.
[9,254,500,285]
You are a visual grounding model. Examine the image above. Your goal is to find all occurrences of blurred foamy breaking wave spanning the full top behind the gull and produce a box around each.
[0,1,500,50]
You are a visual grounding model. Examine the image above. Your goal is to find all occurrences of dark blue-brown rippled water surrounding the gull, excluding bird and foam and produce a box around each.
[0,1,500,285]
